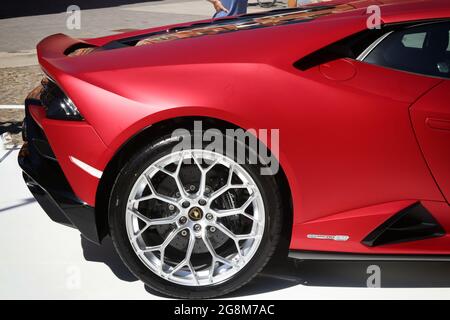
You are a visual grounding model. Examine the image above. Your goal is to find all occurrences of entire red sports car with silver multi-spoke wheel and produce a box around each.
[19,0,450,298]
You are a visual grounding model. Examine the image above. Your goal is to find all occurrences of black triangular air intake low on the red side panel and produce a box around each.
[362,203,445,247]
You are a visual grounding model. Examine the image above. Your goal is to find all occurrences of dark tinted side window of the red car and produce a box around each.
[362,22,450,78]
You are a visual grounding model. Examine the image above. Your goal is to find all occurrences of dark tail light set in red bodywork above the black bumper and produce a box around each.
[41,78,84,121]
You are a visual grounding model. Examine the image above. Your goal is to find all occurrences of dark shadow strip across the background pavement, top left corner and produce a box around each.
[0,0,163,19]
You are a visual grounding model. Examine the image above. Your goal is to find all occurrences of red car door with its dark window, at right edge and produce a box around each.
[363,21,450,201]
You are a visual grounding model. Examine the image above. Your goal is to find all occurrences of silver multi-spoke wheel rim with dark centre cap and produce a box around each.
[125,150,265,286]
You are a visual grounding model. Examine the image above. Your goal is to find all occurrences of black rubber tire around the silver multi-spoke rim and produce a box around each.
[109,131,283,299]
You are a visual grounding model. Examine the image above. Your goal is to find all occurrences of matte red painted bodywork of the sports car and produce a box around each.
[30,0,450,254]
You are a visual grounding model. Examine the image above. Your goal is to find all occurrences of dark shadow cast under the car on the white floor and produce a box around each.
[81,237,450,298]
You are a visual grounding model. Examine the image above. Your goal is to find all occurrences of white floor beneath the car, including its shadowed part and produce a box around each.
[0,149,450,300]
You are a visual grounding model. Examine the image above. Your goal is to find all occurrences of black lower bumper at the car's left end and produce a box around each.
[18,104,100,243]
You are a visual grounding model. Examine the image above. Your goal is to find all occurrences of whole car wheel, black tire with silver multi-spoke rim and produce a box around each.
[109,132,282,298]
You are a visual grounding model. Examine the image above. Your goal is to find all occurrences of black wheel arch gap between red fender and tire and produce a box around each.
[95,116,293,255]
